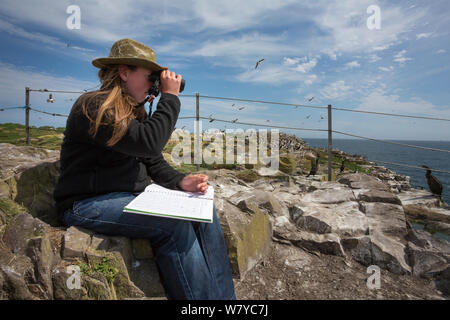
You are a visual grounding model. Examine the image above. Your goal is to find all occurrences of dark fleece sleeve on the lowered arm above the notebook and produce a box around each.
[141,154,186,190]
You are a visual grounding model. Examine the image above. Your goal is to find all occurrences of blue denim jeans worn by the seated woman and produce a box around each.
[64,192,236,300]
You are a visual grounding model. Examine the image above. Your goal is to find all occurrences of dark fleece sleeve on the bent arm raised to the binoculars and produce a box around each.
[94,93,180,158]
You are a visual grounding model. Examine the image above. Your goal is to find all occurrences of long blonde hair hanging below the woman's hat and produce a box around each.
[81,65,146,147]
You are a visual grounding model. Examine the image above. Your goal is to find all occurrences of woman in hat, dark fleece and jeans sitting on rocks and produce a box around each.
[54,39,236,299]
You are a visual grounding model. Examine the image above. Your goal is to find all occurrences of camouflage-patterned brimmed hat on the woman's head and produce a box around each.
[92,38,167,71]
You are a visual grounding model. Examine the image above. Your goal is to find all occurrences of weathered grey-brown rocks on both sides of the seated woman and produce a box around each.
[0,142,450,299]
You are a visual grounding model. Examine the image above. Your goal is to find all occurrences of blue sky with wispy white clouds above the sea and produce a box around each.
[0,0,450,140]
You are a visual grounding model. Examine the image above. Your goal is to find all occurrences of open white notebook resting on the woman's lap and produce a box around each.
[123,183,214,223]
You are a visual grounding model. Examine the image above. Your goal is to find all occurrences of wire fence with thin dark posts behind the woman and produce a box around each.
[0,86,450,179]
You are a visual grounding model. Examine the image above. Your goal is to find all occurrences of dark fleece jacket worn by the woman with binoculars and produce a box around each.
[53,93,185,218]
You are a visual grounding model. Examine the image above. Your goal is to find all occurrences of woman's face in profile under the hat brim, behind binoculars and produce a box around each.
[119,66,152,102]
